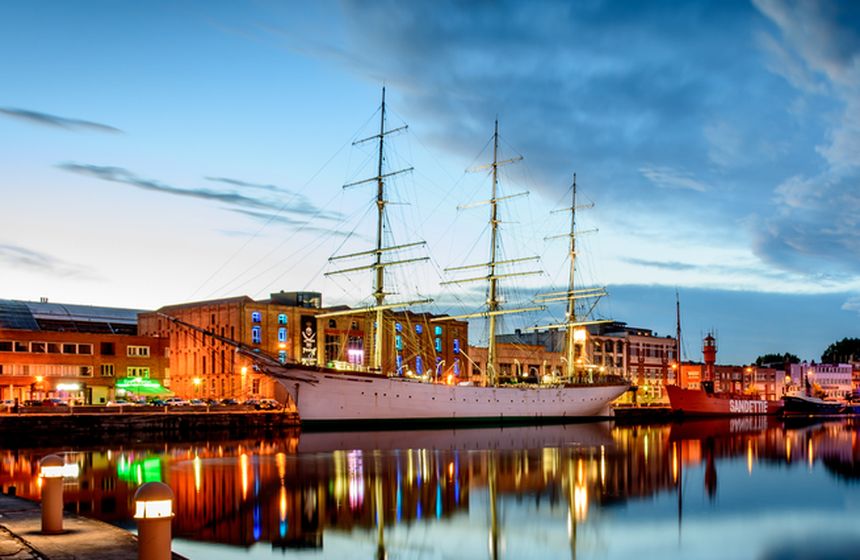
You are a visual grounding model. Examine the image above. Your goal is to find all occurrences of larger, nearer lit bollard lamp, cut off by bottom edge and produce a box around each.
[134,482,173,560]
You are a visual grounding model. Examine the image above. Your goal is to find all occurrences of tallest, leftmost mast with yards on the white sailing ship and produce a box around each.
[317,87,433,373]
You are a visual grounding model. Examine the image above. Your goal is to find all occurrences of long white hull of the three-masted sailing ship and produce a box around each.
[265,366,628,424]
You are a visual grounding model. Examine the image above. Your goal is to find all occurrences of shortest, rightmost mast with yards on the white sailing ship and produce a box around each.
[526,173,611,381]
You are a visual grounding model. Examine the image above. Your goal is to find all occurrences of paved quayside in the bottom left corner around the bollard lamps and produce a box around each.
[0,494,185,560]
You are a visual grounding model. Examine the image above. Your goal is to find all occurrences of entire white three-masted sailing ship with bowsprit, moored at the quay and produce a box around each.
[169,92,629,425]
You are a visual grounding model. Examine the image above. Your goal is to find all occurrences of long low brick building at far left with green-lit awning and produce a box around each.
[0,300,169,404]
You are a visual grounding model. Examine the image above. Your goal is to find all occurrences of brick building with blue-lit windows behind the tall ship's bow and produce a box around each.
[140,292,468,399]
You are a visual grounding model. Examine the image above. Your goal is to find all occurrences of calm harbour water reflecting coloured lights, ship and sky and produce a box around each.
[0,417,860,560]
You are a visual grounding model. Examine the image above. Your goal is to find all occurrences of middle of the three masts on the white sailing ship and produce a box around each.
[430,119,546,387]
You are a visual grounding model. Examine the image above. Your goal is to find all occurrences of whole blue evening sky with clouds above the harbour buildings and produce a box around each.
[0,0,860,364]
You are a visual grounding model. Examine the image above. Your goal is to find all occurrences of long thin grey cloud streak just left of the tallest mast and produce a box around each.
[57,162,342,225]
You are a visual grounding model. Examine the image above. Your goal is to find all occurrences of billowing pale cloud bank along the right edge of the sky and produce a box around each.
[753,0,860,275]
